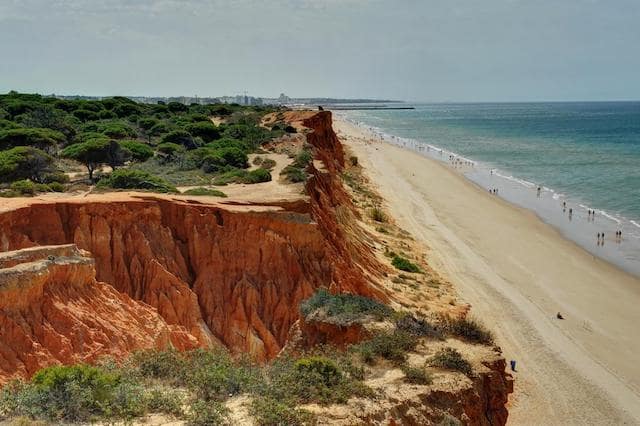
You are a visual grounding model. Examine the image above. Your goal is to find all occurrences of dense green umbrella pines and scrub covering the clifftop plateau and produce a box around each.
[0,92,282,196]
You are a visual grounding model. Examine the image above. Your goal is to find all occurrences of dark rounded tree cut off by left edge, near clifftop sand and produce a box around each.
[0,146,55,182]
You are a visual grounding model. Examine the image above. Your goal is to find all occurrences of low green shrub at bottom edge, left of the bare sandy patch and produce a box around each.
[249,396,314,426]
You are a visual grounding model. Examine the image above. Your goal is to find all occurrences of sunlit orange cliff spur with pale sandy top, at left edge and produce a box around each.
[0,245,197,383]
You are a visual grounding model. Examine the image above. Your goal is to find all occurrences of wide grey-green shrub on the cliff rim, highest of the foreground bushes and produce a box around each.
[300,288,393,323]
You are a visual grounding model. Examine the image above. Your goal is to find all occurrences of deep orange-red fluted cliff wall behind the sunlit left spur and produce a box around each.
[0,113,385,380]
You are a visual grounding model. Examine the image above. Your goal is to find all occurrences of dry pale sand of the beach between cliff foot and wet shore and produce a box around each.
[335,120,640,425]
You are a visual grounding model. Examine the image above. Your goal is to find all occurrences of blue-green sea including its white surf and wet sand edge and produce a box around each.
[337,102,640,276]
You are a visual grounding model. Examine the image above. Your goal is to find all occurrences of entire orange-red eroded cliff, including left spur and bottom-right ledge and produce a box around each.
[0,112,511,425]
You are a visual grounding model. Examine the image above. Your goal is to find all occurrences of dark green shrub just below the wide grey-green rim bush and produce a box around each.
[353,330,418,363]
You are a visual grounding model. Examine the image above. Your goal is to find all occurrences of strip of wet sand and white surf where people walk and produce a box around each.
[339,115,640,278]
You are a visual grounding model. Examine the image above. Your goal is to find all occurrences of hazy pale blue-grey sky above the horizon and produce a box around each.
[0,0,640,102]
